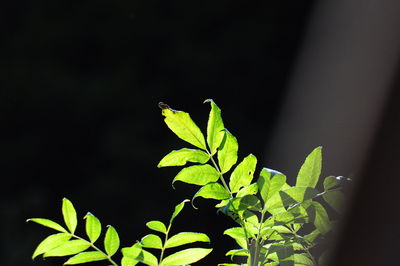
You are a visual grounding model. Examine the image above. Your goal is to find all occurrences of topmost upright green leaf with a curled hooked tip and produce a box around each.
[204,99,224,155]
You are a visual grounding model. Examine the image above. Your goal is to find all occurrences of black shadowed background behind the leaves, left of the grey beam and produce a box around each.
[0,0,399,265]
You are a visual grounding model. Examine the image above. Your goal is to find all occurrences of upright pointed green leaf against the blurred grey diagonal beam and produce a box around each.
[296,147,322,187]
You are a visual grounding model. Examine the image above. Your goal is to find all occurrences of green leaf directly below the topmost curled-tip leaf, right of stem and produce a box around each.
[218,129,239,174]
